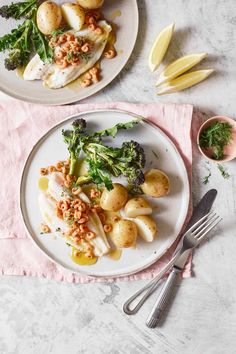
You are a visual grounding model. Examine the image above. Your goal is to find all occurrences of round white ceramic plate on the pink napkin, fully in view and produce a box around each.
[20,110,189,277]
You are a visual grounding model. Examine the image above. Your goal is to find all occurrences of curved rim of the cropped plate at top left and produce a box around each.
[0,0,140,106]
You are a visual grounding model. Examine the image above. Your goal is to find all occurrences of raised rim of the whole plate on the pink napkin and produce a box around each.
[19,108,191,279]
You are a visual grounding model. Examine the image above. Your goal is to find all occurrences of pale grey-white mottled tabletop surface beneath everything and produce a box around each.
[0,0,236,354]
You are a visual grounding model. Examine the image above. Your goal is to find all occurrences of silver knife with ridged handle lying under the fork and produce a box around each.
[146,189,217,328]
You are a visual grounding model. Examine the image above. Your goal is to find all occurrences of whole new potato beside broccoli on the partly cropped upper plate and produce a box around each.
[37,1,62,35]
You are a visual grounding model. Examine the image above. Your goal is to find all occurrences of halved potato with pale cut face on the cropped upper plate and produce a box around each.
[61,3,85,31]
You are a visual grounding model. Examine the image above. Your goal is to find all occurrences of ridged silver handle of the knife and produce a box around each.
[146,267,180,328]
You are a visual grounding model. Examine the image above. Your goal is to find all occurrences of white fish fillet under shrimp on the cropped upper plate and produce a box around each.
[23,21,112,89]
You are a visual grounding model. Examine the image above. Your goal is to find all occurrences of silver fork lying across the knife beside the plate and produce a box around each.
[123,212,222,315]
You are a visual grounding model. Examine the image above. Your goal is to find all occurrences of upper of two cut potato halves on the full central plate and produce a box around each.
[125,197,152,218]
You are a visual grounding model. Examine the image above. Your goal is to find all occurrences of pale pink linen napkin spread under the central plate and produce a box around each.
[0,100,192,283]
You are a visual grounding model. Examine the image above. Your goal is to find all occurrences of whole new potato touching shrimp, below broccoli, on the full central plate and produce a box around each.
[100,183,128,211]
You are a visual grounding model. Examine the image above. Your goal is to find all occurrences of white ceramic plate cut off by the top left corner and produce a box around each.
[0,0,138,105]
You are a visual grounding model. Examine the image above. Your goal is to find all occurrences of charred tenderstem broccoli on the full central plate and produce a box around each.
[62,119,145,190]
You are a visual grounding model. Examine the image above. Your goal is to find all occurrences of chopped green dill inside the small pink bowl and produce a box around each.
[199,121,232,160]
